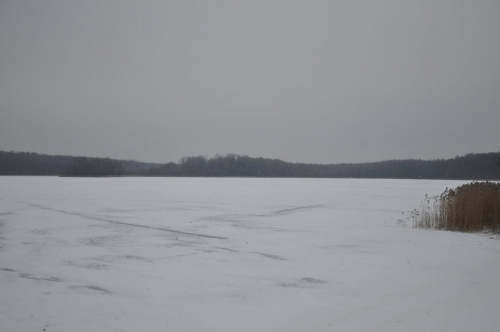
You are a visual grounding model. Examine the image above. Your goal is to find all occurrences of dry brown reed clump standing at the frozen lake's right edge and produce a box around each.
[411,181,500,233]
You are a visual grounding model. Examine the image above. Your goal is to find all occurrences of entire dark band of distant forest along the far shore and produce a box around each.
[0,151,500,180]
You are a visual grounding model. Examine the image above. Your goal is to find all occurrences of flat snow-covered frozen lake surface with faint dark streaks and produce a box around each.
[0,177,500,332]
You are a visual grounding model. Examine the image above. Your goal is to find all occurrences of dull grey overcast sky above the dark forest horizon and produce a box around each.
[0,0,500,163]
